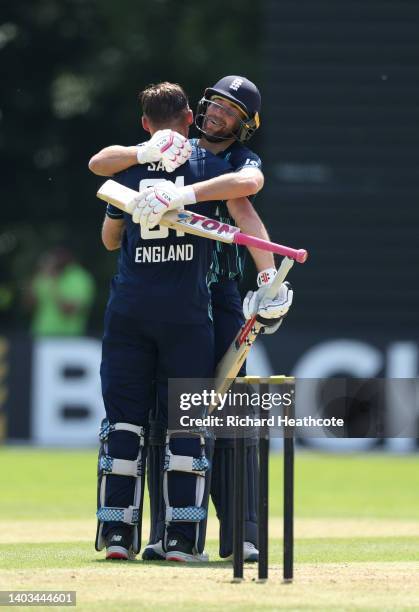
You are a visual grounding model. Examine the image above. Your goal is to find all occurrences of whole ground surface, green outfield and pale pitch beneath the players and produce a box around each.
[0,447,419,612]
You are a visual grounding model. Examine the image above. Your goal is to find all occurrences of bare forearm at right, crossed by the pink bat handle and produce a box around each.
[227,198,275,272]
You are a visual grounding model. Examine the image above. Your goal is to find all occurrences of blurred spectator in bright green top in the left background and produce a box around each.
[28,247,95,336]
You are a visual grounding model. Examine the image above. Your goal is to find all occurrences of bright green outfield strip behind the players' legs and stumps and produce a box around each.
[0,448,419,520]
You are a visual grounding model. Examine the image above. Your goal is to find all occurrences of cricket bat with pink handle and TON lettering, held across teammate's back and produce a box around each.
[97,179,308,263]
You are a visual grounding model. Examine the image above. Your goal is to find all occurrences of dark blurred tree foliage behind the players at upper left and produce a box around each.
[0,0,262,329]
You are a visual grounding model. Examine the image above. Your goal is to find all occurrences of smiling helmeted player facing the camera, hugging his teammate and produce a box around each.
[90,77,292,560]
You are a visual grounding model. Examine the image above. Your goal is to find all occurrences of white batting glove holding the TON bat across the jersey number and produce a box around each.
[126,181,196,229]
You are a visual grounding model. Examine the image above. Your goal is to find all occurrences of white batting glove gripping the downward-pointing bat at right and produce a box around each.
[243,268,294,333]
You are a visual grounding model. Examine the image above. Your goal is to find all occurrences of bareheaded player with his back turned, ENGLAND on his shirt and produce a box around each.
[96,84,238,561]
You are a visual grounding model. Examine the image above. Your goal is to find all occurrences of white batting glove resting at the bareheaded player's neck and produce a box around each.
[137,130,192,172]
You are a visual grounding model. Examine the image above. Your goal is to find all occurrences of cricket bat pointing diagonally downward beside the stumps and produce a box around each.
[210,257,294,402]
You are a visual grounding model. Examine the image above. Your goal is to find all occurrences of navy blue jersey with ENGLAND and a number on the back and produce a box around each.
[107,144,232,324]
